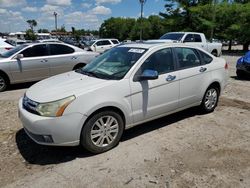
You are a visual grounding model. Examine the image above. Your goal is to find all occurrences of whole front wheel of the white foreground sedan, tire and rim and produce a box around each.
[81,111,124,154]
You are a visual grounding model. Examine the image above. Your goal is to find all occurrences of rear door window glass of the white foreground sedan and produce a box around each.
[175,48,201,69]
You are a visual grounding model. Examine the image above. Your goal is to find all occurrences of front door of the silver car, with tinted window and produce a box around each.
[10,44,49,82]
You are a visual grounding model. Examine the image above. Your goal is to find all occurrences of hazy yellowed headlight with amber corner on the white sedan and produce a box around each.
[36,96,75,117]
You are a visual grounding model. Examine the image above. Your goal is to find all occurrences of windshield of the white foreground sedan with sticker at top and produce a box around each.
[77,47,147,80]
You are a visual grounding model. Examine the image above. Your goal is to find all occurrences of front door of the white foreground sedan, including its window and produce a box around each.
[130,48,179,123]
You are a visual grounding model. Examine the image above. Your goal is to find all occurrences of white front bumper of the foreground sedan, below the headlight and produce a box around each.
[18,98,87,146]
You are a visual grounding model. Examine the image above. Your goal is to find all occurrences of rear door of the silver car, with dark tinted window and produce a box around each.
[48,44,76,76]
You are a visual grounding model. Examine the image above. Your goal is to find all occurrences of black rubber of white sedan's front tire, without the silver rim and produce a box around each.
[81,111,124,154]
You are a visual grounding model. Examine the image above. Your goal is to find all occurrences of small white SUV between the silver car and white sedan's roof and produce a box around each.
[88,39,120,53]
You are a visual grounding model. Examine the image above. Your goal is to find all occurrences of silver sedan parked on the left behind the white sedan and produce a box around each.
[0,42,98,92]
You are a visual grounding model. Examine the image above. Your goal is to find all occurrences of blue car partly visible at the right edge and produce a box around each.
[236,51,250,79]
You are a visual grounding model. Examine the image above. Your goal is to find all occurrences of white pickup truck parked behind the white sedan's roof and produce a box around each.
[158,32,222,56]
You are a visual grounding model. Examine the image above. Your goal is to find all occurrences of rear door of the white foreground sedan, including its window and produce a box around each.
[174,47,211,108]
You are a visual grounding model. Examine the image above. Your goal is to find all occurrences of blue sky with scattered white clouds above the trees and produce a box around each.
[0,0,165,32]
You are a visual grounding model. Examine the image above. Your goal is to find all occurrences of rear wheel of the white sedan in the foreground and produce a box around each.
[200,86,219,113]
